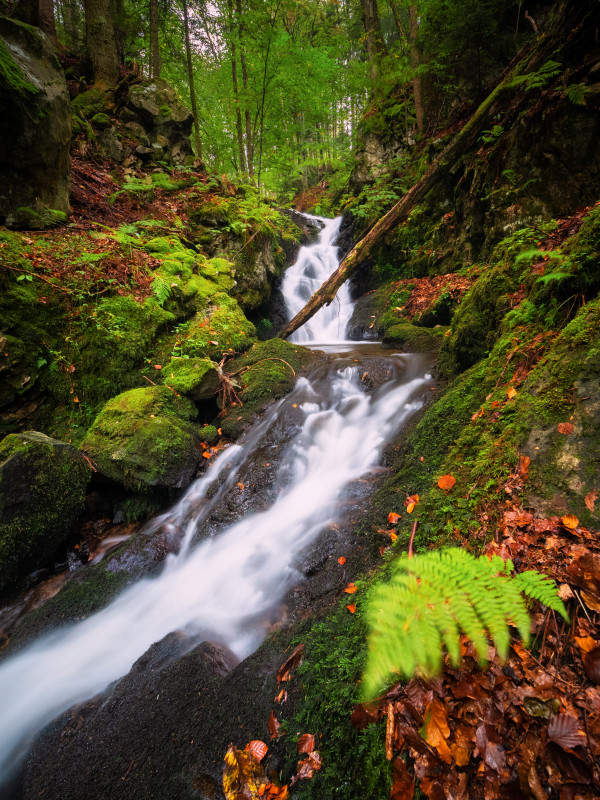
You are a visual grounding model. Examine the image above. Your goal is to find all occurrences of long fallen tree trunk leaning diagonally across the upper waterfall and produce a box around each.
[278,0,580,339]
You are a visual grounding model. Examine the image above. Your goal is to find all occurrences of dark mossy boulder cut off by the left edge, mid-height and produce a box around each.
[0,431,92,589]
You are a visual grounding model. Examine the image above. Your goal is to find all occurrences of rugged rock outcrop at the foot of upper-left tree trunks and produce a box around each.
[121,78,193,164]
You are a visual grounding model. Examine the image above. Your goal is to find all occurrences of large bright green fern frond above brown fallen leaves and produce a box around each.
[363,548,566,698]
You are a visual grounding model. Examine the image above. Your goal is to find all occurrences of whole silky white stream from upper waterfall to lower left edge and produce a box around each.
[0,214,431,783]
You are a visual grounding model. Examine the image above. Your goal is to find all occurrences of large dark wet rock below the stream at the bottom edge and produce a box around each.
[23,634,284,800]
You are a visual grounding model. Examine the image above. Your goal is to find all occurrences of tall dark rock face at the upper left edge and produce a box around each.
[0,17,71,229]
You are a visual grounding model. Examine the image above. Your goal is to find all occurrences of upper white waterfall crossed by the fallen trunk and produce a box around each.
[281,217,353,344]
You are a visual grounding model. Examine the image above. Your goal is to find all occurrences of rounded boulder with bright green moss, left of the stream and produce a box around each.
[81,386,200,491]
